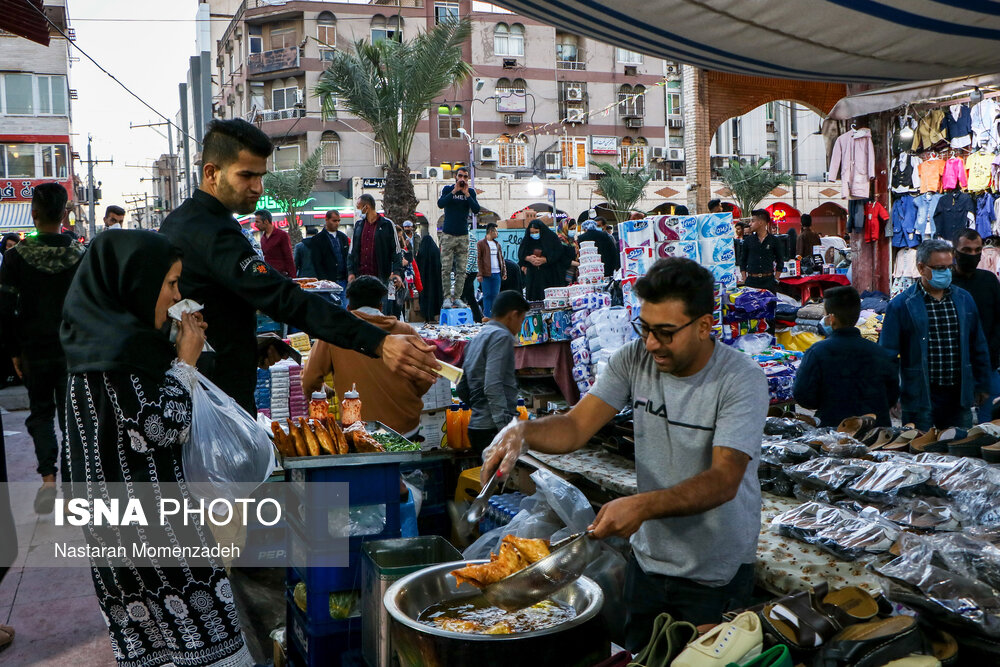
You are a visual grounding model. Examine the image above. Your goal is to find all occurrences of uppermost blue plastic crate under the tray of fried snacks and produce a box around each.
[285,457,400,544]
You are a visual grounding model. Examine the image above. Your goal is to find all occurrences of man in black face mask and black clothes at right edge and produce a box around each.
[951,229,1000,422]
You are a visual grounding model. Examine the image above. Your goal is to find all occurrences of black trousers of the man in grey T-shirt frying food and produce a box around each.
[625,554,754,653]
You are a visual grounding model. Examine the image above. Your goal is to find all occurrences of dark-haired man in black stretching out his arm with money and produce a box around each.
[160,118,438,414]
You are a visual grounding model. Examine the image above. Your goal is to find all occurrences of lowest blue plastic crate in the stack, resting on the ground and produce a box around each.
[285,601,362,667]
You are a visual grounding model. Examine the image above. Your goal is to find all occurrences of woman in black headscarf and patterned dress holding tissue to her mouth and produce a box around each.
[61,231,253,667]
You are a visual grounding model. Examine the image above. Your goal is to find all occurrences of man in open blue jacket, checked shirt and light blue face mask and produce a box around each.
[879,239,990,431]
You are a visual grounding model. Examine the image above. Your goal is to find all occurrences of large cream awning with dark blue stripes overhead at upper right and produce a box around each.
[495,0,1000,84]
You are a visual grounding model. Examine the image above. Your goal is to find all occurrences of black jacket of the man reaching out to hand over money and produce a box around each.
[160,190,386,414]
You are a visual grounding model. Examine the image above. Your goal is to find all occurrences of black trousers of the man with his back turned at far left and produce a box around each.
[21,357,66,476]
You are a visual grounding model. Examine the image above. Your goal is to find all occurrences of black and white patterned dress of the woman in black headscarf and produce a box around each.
[66,366,254,667]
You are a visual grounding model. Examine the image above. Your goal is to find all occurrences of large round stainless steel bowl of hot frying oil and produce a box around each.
[383,561,611,667]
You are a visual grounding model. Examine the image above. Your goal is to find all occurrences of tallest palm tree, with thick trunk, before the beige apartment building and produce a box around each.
[313,19,472,221]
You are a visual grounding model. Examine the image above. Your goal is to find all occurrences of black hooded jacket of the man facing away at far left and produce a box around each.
[0,234,86,362]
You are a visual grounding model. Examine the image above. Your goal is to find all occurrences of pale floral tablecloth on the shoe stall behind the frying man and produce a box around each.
[521,446,879,595]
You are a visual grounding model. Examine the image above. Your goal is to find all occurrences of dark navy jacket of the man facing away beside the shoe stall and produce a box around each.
[792,327,899,428]
